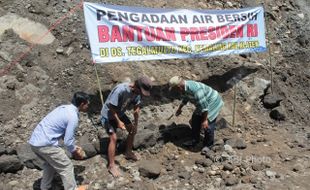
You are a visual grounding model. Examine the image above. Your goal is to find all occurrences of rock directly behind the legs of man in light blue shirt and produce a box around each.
[17,143,44,169]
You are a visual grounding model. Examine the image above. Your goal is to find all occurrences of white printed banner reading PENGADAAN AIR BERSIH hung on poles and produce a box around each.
[84,2,266,63]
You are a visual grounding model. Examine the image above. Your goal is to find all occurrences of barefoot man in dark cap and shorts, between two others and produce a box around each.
[101,76,152,177]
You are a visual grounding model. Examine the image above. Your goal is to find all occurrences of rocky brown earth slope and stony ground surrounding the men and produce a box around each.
[0,0,310,190]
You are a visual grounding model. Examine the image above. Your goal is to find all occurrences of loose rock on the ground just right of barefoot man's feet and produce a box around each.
[139,160,161,178]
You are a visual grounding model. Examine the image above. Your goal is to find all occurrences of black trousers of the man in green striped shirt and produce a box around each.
[191,113,216,147]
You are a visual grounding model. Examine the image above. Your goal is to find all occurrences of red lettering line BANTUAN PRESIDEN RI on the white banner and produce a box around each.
[98,24,247,43]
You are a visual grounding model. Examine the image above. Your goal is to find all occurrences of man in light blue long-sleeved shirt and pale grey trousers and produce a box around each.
[28,92,89,190]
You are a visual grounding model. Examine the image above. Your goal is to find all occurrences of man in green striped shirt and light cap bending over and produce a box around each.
[169,76,224,147]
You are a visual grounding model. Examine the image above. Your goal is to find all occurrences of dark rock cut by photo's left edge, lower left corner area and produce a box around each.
[0,155,23,173]
